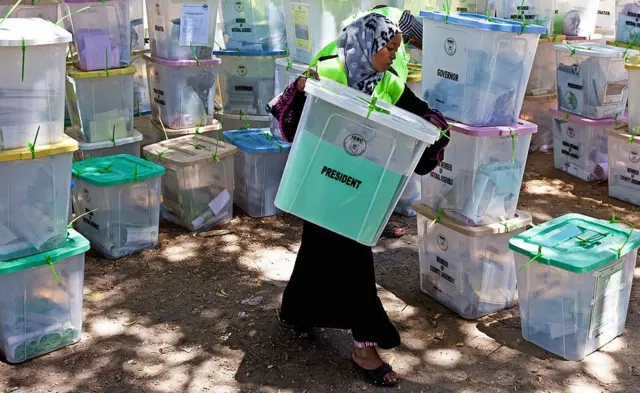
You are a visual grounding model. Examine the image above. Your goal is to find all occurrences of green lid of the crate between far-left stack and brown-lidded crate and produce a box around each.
[73,154,164,187]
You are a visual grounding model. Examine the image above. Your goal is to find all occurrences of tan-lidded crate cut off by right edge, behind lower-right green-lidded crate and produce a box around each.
[607,127,640,206]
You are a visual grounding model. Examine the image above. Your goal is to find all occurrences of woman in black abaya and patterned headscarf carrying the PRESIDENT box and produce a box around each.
[273,13,448,386]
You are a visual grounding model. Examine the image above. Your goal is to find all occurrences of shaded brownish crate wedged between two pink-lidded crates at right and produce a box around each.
[520,94,558,152]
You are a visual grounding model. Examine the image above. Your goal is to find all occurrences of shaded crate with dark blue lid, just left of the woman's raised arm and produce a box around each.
[214,50,284,116]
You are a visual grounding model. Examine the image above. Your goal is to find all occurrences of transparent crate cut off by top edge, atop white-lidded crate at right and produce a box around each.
[553,0,600,37]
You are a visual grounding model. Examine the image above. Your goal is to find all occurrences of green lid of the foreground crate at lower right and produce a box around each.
[509,214,640,273]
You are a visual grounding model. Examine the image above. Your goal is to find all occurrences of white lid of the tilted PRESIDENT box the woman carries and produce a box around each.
[304,78,440,143]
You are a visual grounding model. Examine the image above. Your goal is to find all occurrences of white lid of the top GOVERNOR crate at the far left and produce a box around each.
[0,18,71,46]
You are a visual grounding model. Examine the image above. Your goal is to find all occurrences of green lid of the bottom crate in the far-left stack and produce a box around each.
[0,229,89,274]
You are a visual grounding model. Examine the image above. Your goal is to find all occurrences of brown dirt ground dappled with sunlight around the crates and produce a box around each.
[0,153,640,393]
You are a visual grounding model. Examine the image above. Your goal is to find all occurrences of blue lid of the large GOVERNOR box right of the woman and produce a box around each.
[420,11,547,34]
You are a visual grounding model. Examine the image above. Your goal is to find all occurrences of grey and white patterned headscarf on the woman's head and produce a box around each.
[338,13,400,94]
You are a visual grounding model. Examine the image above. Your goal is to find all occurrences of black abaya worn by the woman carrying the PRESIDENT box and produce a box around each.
[280,84,448,349]
